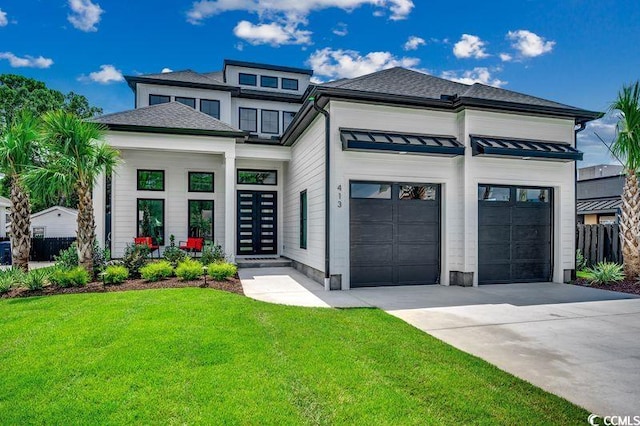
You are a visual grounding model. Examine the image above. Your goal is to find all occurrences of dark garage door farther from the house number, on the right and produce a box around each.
[478,185,553,284]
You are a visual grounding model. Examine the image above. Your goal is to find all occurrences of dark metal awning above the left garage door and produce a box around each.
[340,129,464,157]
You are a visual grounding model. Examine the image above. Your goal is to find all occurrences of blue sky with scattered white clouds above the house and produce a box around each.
[0,0,640,165]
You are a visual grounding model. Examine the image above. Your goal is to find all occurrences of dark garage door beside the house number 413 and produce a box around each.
[349,182,440,287]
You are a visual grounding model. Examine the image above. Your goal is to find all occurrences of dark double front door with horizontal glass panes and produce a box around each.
[238,191,278,255]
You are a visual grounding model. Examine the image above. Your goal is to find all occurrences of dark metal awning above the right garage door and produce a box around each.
[471,135,582,161]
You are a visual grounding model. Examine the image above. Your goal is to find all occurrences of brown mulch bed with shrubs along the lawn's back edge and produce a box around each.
[2,277,244,299]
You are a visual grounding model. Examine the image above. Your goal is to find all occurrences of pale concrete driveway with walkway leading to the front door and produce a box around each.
[240,268,640,415]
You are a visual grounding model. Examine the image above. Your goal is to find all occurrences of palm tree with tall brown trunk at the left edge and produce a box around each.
[0,111,39,271]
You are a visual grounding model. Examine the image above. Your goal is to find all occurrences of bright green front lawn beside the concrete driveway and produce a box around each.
[0,288,588,425]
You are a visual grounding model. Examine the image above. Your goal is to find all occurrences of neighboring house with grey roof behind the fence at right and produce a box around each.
[576,164,625,225]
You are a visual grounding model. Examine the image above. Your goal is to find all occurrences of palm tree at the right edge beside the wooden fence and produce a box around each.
[610,81,640,279]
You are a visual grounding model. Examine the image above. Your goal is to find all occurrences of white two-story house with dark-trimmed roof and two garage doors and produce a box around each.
[94,61,600,289]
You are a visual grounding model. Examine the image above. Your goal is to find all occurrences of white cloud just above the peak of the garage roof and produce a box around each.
[307,47,420,79]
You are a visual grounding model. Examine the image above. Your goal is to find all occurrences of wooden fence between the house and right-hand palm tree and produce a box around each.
[576,224,622,266]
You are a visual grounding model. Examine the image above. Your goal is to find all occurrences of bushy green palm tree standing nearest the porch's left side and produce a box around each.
[26,111,119,275]
